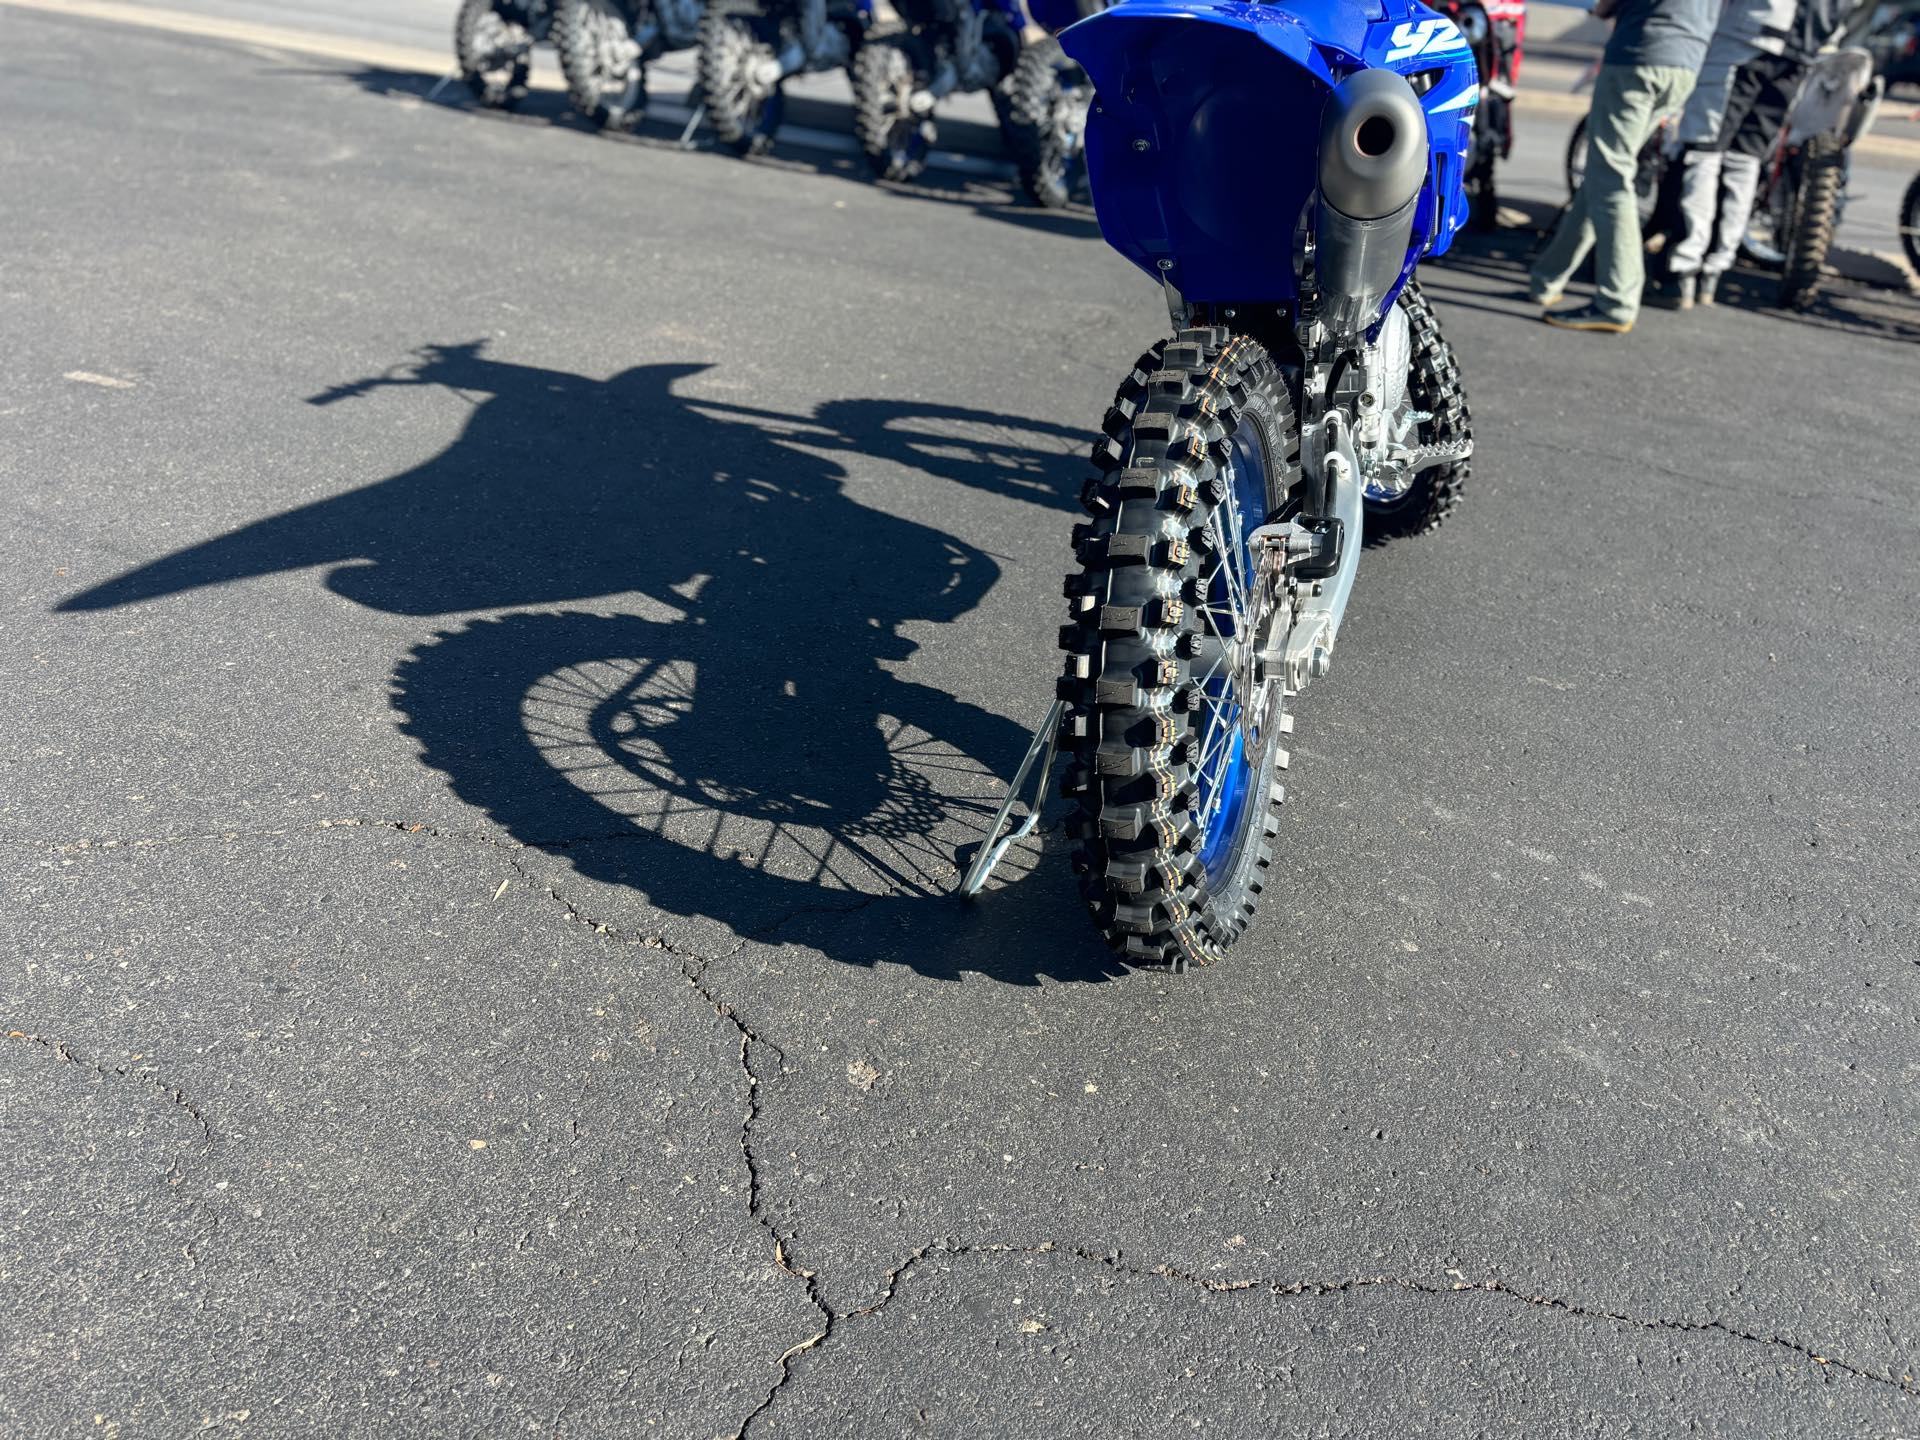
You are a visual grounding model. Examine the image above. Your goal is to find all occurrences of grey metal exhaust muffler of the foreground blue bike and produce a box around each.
[1313,69,1428,334]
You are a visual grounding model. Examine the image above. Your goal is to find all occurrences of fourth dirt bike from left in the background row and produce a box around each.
[852,0,1027,180]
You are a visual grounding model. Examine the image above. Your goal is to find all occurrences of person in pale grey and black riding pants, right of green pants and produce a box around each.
[1670,0,1841,309]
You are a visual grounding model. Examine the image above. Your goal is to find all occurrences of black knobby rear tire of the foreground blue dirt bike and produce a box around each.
[1060,328,1300,970]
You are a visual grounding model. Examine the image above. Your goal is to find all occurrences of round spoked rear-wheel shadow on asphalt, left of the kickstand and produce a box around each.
[394,612,1020,927]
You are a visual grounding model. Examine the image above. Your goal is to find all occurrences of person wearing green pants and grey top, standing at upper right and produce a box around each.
[1526,0,1718,334]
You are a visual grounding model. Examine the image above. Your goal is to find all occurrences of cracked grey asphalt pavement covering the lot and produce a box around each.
[0,6,1920,1440]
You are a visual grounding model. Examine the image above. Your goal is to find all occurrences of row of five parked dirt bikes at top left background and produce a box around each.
[453,0,1102,207]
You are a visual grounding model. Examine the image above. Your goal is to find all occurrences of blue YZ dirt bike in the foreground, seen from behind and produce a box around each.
[1054,0,1480,970]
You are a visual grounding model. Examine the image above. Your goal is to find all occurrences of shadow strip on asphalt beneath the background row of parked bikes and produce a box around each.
[312,65,1100,240]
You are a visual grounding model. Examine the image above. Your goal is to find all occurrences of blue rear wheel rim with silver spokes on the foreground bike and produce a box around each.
[1194,428,1267,887]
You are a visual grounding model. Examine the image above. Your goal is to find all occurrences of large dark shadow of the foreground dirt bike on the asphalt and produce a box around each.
[60,342,1119,985]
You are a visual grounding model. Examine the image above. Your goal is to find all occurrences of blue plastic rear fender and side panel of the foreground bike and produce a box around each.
[1060,0,1480,303]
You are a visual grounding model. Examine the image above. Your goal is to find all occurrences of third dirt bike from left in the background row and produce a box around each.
[701,0,874,156]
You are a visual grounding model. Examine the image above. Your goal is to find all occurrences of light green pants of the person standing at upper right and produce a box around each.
[1532,65,1693,324]
